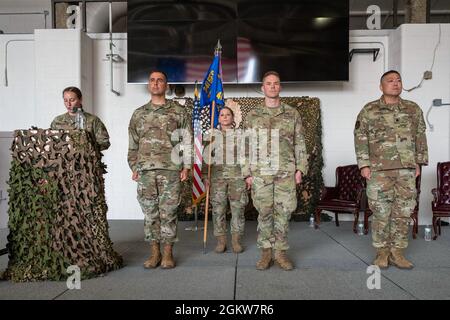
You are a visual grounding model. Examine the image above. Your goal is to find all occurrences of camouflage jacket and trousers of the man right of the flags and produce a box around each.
[242,103,307,250]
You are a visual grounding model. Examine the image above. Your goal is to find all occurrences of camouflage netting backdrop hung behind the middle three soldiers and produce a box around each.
[179,97,328,221]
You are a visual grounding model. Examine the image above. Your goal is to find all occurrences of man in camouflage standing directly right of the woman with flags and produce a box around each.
[242,71,307,270]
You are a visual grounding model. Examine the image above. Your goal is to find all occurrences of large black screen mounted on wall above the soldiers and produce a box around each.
[127,0,349,84]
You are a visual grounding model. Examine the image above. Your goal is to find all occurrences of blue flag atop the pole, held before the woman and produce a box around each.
[200,51,225,128]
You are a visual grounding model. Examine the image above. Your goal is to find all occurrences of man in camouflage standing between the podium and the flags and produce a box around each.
[128,71,191,269]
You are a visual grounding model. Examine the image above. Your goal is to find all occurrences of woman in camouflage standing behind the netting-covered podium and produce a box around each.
[50,87,111,151]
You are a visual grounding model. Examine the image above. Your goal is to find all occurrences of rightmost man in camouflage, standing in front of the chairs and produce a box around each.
[354,70,428,269]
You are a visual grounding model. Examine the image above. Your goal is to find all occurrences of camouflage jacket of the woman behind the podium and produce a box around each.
[50,111,111,151]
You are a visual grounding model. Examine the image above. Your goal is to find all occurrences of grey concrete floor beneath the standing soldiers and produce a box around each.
[0,220,450,300]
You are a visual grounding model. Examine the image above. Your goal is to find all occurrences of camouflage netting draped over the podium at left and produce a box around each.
[4,129,122,281]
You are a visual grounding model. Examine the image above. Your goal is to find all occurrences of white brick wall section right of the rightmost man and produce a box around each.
[398,24,450,224]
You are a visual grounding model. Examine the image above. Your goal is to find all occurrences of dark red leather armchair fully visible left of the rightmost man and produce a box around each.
[315,164,366,233]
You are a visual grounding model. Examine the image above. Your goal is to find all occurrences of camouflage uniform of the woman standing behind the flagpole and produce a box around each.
[203,129,248,237]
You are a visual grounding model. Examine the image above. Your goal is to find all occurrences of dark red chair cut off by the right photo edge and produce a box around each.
[431,162,450,240]
